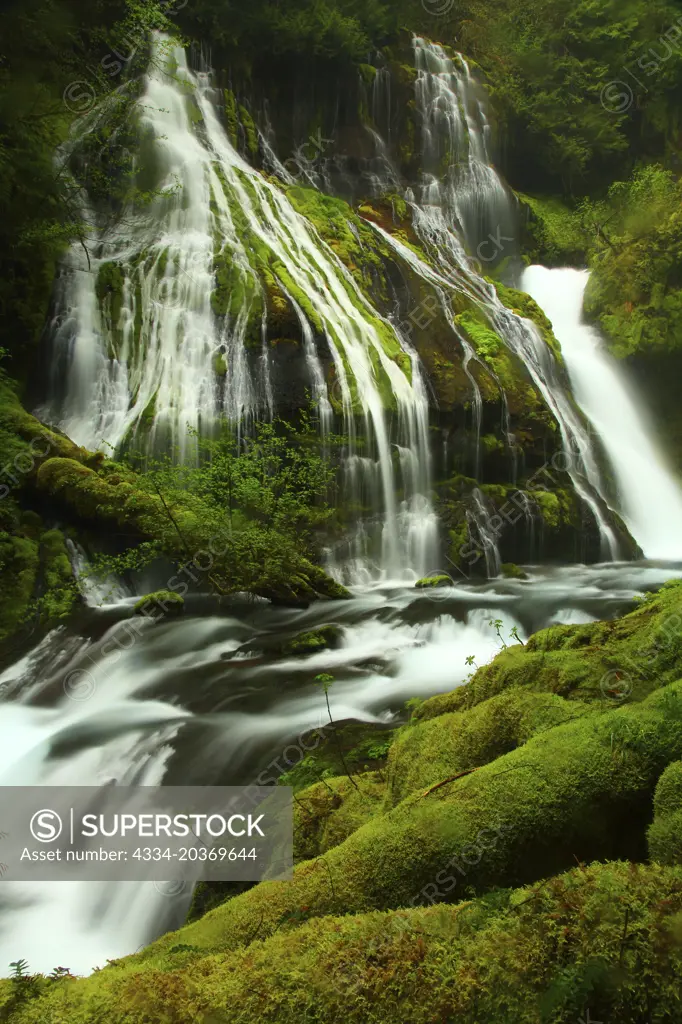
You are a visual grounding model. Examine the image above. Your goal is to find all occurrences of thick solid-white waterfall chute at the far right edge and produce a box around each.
[523,266,682,560]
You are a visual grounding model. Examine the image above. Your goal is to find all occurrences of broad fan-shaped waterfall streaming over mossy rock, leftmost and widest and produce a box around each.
[42,36,435,582]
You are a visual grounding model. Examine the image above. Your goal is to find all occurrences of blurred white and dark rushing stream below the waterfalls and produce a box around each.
[0,564,675,973]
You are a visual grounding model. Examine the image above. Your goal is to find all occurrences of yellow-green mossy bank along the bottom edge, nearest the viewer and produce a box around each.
[5,862,682,1024]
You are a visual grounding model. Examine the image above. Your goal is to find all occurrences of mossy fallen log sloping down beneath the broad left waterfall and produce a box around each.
[0,384,349,635]
